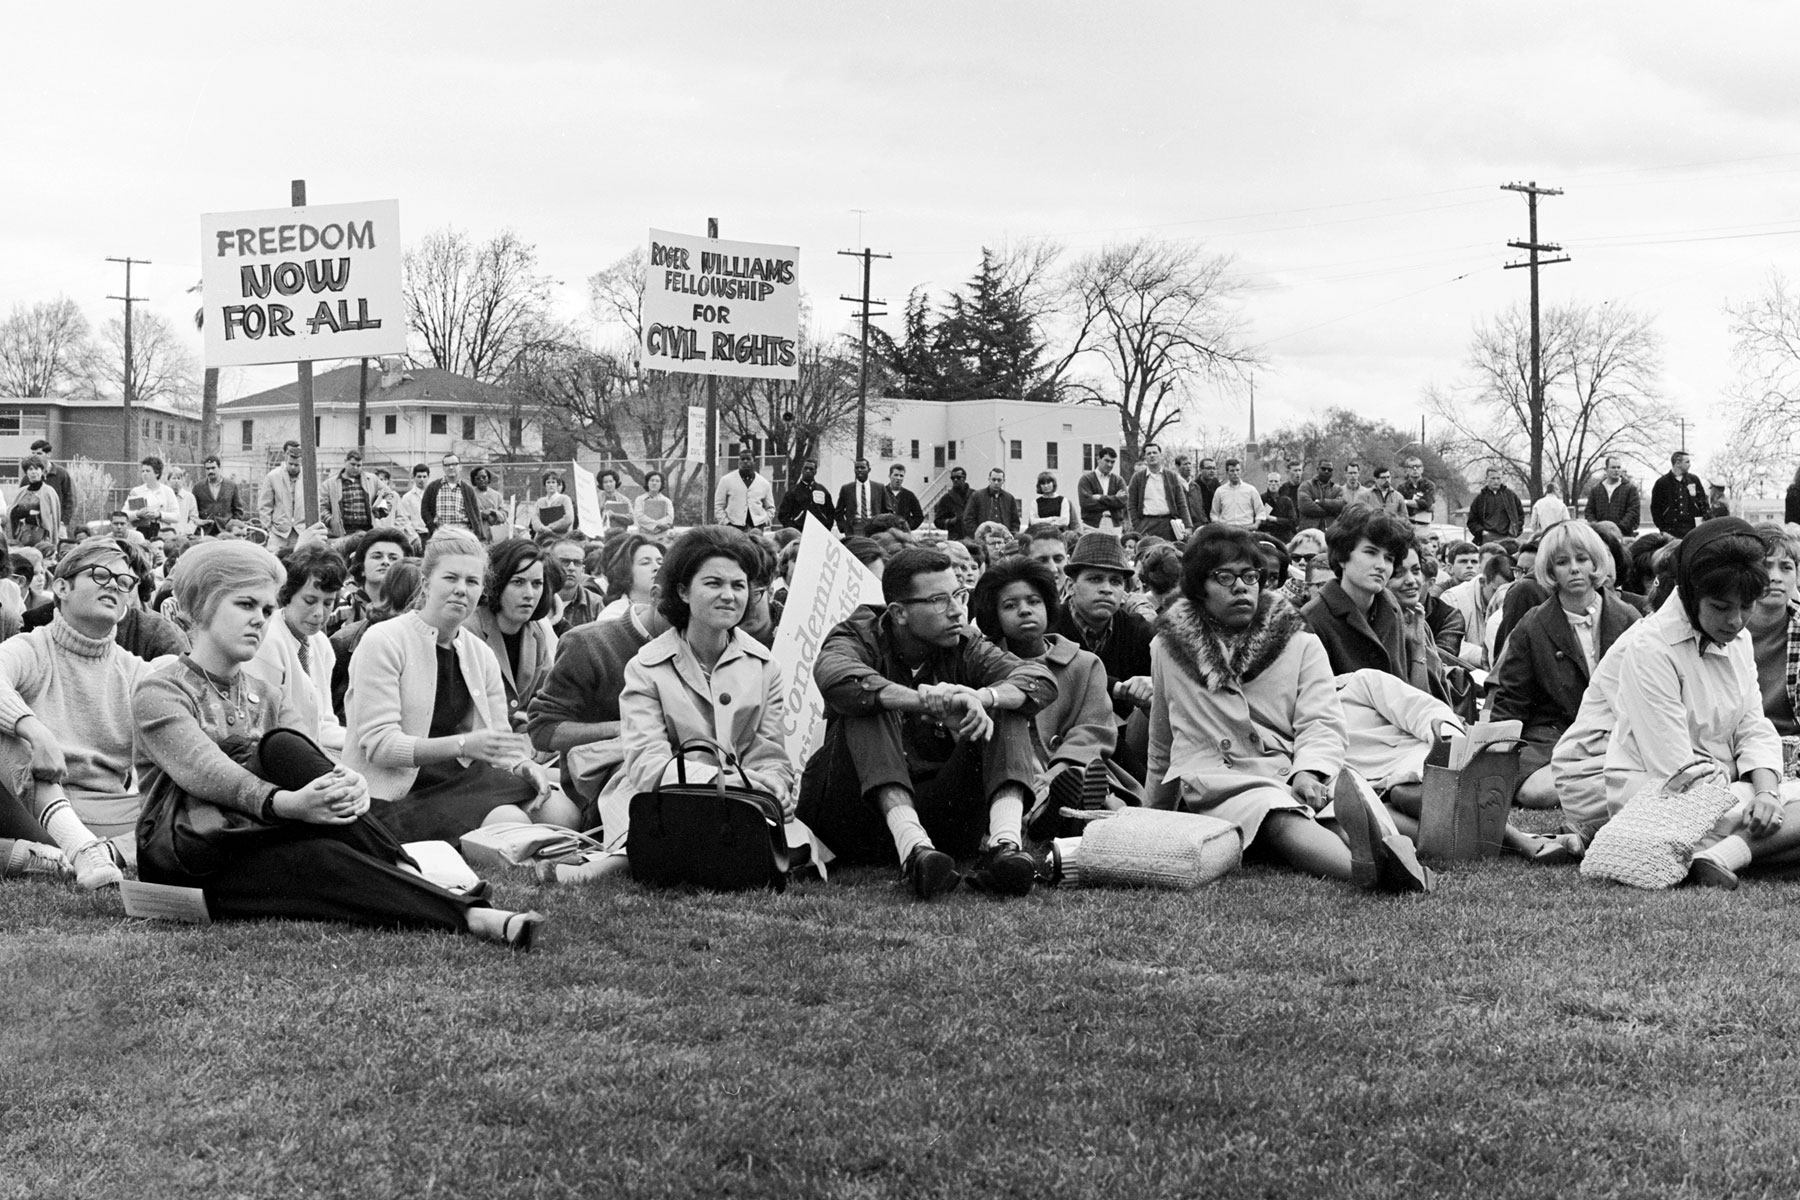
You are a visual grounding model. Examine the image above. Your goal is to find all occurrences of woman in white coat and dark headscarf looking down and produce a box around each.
[1552,516,1800,887]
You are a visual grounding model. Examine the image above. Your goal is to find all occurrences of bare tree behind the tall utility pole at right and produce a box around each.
[1426,304,1676,500]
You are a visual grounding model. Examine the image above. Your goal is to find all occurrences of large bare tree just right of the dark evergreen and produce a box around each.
[1057,237,1258,462]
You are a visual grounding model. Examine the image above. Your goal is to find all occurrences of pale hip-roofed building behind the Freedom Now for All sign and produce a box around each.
[220,363,544,479]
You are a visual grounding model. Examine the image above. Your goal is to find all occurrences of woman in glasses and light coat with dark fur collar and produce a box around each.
[1145,525,1429,891]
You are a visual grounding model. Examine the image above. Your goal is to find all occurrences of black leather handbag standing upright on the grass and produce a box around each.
[625,738,788,892]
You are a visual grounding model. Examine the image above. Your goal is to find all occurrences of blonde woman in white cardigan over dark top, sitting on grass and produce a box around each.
[344,529,574,842]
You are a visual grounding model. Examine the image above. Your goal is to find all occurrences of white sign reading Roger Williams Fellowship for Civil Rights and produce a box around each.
[643,228,799,380]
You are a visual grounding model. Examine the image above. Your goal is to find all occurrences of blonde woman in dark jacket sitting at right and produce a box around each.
[1492,520,1638,808]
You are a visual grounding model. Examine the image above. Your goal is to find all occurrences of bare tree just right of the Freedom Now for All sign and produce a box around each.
[403,228,554,383]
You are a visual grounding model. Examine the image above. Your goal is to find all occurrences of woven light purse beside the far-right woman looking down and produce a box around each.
[1580,763,1737,889]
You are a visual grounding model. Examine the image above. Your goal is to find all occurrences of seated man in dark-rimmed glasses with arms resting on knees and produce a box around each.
[799,547,1057,900]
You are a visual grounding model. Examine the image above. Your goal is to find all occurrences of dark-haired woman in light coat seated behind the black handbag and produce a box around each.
[554,525,794,882]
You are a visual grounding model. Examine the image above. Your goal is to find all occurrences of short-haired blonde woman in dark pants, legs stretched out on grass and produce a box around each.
[131,542,542,950]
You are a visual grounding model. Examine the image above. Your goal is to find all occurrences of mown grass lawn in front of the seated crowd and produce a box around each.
[0,820,1800,1200]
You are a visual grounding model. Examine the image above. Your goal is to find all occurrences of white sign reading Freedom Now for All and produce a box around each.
[200,200,407,367]
